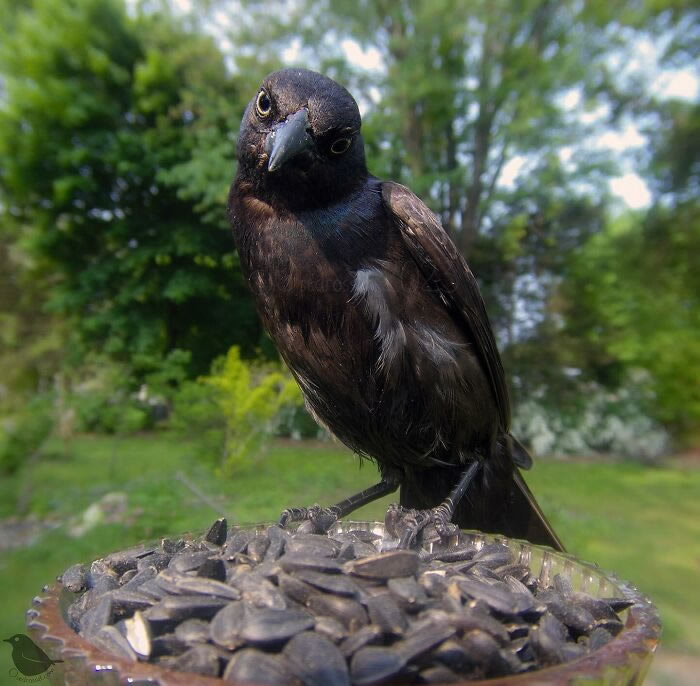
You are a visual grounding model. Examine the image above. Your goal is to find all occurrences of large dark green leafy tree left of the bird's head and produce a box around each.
[0,0,260,372]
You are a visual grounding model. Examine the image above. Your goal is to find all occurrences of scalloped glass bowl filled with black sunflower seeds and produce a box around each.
[27,519,661,686]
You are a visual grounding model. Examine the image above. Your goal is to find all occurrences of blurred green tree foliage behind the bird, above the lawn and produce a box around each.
[0,0,699,452]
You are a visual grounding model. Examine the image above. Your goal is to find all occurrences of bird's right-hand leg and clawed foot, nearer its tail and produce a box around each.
[384,461,481,549]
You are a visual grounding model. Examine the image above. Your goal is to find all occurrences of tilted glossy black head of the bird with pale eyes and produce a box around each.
[238,69,367,208]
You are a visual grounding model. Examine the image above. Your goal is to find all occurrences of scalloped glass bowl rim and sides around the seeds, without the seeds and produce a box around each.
[27,521,661,686]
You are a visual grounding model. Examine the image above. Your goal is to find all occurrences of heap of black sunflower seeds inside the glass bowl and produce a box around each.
[61,519,631,686]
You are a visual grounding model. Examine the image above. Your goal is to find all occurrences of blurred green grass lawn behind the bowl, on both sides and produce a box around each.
[0,433,700,674]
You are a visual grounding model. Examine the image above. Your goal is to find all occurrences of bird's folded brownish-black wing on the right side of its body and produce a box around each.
[382,182,510,431]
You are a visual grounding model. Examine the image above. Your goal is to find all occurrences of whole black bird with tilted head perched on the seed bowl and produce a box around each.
[229,69,563,549]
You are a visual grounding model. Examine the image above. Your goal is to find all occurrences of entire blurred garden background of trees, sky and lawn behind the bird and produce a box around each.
[0,0,700,684]
